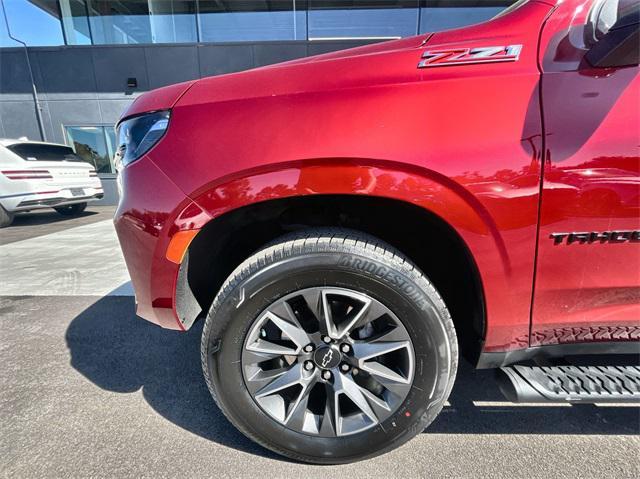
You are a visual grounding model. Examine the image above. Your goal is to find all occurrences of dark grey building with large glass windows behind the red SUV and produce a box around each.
[0,0,514,204]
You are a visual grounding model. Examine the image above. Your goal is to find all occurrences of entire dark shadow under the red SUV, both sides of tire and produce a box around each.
[66,296,639,458]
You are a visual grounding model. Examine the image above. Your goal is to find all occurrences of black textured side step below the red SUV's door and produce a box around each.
[498,365,640,403]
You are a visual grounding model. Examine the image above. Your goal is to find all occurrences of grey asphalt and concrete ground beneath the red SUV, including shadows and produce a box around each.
[0,209,640,478]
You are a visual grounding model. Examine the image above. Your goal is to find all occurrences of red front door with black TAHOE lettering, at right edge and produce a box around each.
[531,2,640,346]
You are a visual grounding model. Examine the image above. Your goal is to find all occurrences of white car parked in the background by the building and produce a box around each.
[0,139,104,228]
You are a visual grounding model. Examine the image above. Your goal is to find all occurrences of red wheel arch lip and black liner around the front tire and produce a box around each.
[175,162,506,359]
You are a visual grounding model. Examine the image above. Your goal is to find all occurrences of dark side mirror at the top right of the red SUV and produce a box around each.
[584,5,640,68]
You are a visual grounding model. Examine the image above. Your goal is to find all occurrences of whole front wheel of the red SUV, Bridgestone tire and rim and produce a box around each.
[202,229,458,464]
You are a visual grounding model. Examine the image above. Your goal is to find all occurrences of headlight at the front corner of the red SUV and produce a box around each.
[115,111,169,169]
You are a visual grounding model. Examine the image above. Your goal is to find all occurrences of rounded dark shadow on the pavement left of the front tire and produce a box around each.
[65,296,276,458]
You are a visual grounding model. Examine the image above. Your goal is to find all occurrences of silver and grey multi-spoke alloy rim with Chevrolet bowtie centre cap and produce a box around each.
[242,287,415,437]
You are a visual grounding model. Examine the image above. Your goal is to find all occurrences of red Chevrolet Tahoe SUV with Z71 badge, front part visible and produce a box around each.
[115,0,640,463]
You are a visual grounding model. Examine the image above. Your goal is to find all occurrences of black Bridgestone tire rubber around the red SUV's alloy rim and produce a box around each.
[201,228,458,464]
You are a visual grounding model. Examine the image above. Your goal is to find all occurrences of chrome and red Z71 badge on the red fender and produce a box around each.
[418,45,522,68]
